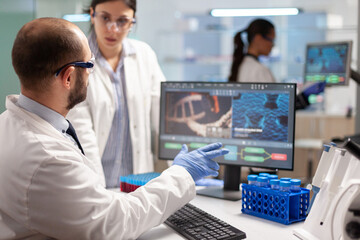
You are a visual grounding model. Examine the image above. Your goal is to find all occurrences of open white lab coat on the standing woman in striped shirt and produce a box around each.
[67,39,165,186]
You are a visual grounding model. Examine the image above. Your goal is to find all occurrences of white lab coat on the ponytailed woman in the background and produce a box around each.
[236,56,276,83]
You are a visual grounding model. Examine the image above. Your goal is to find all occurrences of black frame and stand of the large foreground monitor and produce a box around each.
[158,82,296,201]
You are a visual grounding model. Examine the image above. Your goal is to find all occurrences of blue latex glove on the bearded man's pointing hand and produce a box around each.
[173,143,229,181]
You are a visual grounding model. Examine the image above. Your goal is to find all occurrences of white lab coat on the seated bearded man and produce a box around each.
[0,95,195,240]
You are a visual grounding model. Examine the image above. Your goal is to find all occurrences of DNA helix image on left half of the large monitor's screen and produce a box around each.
[165,92,232,138]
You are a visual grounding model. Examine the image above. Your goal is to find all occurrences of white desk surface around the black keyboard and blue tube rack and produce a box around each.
[138,195,304,240]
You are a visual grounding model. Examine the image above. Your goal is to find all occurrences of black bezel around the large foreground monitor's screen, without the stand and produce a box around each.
[157,81,297,171]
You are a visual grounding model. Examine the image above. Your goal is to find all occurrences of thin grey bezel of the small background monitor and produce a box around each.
[303,40,352,87]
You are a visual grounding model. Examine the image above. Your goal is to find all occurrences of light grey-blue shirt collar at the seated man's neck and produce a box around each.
[18,94,69,133]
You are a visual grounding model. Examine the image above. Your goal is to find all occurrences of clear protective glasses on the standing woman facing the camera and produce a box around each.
[93,12,136,32]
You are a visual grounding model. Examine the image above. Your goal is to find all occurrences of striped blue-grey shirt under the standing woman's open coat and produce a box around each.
[89,33,135,188]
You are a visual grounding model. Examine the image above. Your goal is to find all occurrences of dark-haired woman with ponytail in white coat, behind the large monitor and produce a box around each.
[229,19,275,82]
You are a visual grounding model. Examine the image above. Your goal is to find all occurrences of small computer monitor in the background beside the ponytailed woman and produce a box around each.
[304,41,352,86]
